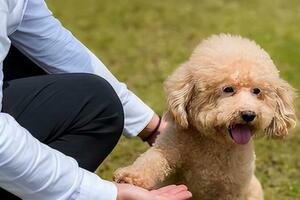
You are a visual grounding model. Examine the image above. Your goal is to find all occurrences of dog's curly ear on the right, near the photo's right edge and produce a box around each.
[265,80,296,138]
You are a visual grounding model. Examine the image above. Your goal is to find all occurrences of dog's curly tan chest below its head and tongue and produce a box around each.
[178,140,254,200]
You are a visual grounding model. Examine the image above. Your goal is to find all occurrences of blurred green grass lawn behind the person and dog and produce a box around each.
[47,0,300,200]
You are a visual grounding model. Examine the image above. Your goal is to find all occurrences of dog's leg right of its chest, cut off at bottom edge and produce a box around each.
[246,175,264,200]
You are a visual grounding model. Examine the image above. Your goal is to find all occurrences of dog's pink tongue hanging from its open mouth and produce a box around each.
[231,124,251,144]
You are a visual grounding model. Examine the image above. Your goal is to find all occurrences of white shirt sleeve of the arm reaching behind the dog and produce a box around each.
[10,0,154,136]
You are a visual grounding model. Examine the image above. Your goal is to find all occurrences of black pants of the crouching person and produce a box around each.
[0,45,124,200]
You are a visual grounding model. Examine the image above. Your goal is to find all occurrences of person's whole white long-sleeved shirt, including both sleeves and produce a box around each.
[0,0,153,200]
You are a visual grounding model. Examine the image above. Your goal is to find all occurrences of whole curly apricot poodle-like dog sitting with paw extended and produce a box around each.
[114,35,295,200]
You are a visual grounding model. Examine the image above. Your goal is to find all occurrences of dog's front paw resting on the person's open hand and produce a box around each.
[113,167,154,189]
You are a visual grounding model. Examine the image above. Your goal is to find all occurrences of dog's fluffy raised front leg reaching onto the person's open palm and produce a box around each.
[114,147,174,189]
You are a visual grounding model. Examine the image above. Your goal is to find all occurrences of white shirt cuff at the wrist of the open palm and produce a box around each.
[72,171,118,200]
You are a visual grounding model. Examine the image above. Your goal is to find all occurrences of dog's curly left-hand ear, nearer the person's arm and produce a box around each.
[164,63,194,128]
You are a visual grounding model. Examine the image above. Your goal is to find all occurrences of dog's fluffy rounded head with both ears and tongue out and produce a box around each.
[165,34,296,144]
